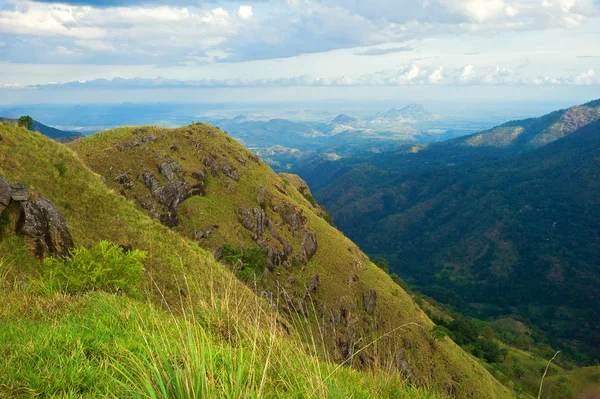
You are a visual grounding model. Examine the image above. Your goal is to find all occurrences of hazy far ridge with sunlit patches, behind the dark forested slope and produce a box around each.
[294,99,600,193]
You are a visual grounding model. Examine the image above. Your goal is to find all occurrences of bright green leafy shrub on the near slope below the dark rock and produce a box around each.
[43,241,147,296]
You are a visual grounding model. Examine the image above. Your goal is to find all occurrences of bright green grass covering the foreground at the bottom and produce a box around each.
[0,290,439,399]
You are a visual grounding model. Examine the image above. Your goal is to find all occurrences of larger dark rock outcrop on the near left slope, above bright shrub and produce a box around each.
[16,197,74,258]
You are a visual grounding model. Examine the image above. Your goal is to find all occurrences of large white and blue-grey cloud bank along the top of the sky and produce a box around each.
[0,0,597,63]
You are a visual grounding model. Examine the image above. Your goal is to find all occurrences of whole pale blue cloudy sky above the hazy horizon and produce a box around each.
[0,0,600,105]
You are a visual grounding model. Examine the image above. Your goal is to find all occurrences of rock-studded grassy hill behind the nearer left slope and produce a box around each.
[70,124,511,398]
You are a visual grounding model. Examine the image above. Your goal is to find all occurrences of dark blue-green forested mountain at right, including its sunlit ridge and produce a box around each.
[300,101,600,362]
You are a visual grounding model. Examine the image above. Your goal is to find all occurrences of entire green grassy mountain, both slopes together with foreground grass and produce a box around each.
[0,123,512,399]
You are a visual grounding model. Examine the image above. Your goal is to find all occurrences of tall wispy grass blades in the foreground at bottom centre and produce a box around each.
[111,276,436,399]
